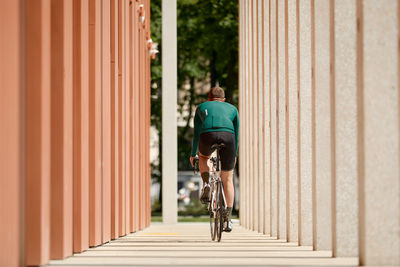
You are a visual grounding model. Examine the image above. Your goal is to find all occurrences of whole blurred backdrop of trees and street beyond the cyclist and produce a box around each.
[151,0,239,221]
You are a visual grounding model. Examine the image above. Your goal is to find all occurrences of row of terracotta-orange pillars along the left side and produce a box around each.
[0,0,152,266]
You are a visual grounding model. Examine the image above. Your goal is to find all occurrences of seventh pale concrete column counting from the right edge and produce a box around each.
[270,0,279,237]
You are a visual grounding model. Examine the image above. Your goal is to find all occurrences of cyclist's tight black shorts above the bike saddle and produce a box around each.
[199,131,236,171]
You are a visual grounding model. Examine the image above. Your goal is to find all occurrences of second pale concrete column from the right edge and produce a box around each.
[331,0,358,257]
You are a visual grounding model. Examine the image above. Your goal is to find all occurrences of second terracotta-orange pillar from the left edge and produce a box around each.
[25,0,50,265]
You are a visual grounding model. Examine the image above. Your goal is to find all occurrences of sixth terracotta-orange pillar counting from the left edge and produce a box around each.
[101,1,111,243]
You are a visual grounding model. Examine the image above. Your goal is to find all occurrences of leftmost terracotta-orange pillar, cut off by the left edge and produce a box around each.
[0,0,25,267]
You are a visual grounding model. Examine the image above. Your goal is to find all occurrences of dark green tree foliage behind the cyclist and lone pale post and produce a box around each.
[151,0,239,182]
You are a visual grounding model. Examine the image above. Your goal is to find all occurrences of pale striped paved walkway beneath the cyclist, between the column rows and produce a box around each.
[43,223,357,267]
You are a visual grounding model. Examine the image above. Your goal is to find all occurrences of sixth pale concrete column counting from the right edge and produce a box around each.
[276,1,287,239]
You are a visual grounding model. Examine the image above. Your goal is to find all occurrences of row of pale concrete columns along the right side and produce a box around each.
[239,0,400,265]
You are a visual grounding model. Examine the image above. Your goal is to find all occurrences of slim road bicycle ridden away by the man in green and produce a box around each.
[194,143,227,242]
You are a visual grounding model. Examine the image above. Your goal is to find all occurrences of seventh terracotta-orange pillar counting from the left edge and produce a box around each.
[110,0,119,239]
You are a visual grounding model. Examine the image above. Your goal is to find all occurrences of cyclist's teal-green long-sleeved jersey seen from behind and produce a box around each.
[191,101,239,157]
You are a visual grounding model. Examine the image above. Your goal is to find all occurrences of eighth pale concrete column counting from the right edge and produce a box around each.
[261,1,271,238]
